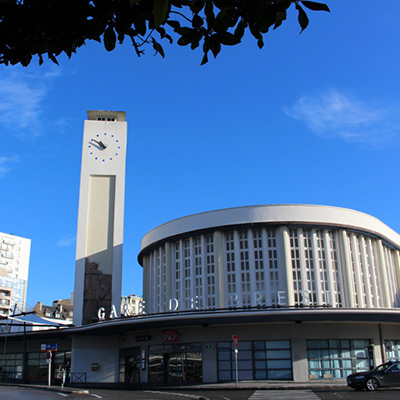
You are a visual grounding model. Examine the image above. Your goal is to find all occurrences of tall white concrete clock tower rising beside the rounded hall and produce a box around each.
[74,111,127,325]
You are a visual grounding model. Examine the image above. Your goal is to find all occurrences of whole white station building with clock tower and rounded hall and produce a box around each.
[0,111,400,386]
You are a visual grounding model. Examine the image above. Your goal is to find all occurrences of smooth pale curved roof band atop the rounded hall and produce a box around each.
[141,204,400,251]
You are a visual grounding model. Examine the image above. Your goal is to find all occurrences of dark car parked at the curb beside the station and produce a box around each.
[347,361,400,390]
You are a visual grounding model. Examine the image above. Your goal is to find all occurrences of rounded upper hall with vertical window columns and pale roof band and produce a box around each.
[139,205,400,313]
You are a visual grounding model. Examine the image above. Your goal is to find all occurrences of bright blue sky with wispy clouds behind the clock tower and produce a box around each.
[0,0,400,307]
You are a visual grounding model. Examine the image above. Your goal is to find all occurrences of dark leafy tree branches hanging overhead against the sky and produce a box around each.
[0,0,329,66]
